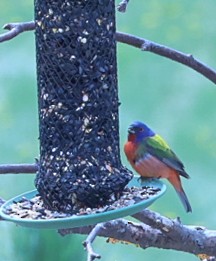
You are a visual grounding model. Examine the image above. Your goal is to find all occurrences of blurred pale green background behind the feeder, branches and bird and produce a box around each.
[0,0,216,261]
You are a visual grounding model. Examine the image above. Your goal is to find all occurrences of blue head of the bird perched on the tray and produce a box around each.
[128,121,155,143]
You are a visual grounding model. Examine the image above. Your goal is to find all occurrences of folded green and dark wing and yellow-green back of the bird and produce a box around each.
[136,134,189,178]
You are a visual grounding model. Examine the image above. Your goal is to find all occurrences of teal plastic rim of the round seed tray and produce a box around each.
[0,177,166,229]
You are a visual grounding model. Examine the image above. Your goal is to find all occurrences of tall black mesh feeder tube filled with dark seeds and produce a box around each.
[35,0,132,213]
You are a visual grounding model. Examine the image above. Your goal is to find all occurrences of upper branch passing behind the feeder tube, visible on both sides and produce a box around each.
[0,21,216,84]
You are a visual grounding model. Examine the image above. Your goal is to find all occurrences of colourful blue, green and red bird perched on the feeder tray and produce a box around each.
[124,121,192,212]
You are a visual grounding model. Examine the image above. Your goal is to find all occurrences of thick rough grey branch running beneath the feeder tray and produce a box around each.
[59,211,216,256]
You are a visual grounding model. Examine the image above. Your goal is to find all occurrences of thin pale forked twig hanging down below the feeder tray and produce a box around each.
[83,223,104,261]
